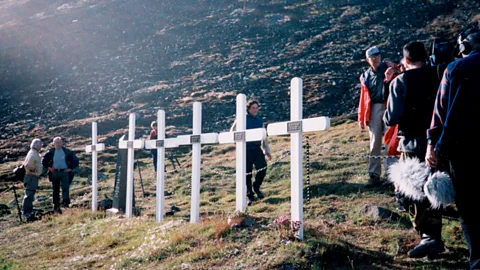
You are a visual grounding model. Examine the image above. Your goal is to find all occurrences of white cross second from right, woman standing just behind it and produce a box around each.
[218,94,267,212]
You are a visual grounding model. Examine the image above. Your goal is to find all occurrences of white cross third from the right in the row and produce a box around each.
[177,102,218,223]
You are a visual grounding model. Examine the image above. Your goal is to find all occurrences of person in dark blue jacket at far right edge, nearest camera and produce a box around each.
[425,25,480,269]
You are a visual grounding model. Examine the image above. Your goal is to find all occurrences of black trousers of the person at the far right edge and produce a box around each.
[450,157,480,269]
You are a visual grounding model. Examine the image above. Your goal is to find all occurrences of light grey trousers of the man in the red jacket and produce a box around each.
[368,103,388,177]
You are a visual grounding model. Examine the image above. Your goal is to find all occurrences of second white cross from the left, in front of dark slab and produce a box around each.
[118,113,144,218]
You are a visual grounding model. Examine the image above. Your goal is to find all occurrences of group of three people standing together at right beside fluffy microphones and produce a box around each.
[358,23,480,269]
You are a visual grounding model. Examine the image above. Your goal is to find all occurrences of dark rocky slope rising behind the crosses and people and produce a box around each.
[0,0,480,162]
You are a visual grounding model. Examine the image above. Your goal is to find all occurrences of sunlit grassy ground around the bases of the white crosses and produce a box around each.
[0,119,468,269]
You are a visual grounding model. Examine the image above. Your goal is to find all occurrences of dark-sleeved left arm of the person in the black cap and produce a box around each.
[383,77,405,126]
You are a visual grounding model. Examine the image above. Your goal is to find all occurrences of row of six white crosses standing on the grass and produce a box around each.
[87,78,330,240]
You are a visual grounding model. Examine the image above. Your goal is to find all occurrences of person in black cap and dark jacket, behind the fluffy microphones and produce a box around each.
[383,41,445,258]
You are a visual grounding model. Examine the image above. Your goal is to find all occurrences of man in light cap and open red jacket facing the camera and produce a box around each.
[358,46,398,187]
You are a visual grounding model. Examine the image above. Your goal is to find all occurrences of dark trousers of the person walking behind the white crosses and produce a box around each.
[247,147,267,198]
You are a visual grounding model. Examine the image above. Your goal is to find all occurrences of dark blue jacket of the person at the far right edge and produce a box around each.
[427,49,480,158]
